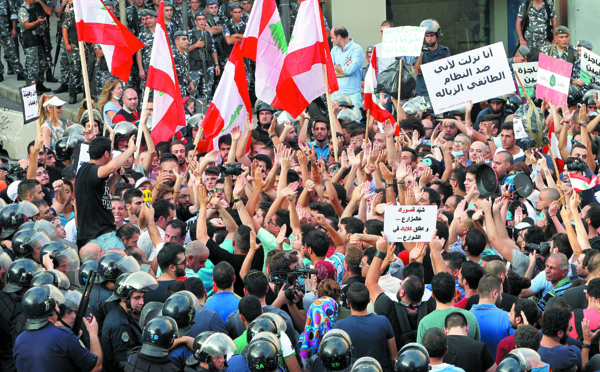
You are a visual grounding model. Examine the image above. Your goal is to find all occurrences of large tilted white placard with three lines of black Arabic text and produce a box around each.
[421,43,515,114]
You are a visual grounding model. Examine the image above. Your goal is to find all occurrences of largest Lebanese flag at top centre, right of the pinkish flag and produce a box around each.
[272,0,339,117]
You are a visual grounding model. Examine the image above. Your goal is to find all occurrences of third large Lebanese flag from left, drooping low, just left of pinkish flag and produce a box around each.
[198,43,252,152]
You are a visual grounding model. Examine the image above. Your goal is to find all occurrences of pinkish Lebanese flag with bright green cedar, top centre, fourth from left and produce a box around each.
[241,0,288,104]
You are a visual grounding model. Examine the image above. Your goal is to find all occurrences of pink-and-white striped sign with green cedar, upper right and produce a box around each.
[535,54,573,107]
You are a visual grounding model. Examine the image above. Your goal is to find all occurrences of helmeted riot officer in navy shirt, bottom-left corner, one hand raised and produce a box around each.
[14,284,102,372]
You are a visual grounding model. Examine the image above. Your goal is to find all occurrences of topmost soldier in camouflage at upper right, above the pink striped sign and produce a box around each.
[516,0,556,53]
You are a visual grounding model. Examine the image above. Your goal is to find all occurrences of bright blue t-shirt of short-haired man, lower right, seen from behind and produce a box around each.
[471,304,515,359]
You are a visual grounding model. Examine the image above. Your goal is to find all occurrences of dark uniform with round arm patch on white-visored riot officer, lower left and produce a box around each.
[101,302,142,372]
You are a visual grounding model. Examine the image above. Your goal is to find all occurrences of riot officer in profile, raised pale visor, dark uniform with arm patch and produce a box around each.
[101,271,158,371]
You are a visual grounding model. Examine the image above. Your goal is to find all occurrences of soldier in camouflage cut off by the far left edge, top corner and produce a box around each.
[0,0,25,81]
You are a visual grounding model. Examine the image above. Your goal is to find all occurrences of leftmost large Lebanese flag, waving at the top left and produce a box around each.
[73,0,144,82]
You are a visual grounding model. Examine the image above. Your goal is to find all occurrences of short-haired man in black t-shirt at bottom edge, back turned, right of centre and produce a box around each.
[444,313,496,372]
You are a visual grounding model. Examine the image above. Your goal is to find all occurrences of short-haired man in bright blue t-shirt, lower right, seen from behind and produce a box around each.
[471,275,515,359]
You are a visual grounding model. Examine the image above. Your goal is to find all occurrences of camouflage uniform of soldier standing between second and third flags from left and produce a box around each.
[188,29,217,102]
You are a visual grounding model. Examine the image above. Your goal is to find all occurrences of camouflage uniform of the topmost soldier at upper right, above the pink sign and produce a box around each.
[517,0,556,53]
